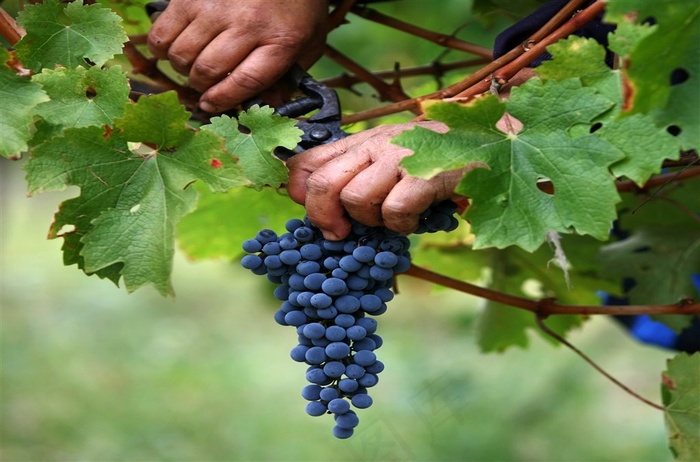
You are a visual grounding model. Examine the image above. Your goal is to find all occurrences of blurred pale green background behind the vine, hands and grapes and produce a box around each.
[0,0,671,461]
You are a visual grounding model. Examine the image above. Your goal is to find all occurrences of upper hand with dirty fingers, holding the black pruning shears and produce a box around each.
[148,0,328,113]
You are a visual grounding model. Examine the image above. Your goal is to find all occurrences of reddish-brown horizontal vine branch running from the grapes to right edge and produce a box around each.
[403,265,700,319]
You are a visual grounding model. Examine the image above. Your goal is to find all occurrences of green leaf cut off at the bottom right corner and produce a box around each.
[661,353,700,461]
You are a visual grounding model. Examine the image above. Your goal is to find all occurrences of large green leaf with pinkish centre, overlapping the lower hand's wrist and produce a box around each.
[394,79,624,251]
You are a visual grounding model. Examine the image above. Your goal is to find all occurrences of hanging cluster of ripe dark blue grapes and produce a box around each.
[241,201,458,438]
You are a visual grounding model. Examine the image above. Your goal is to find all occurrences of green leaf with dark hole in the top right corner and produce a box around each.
[606,0,700,149]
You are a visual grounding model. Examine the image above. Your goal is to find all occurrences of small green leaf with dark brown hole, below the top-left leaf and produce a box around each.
[32,66,130,128]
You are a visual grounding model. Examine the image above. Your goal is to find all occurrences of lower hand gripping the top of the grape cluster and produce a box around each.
[287,122,464,240]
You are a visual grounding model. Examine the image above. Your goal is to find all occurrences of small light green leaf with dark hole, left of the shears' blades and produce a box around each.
[202,106,302,189]
